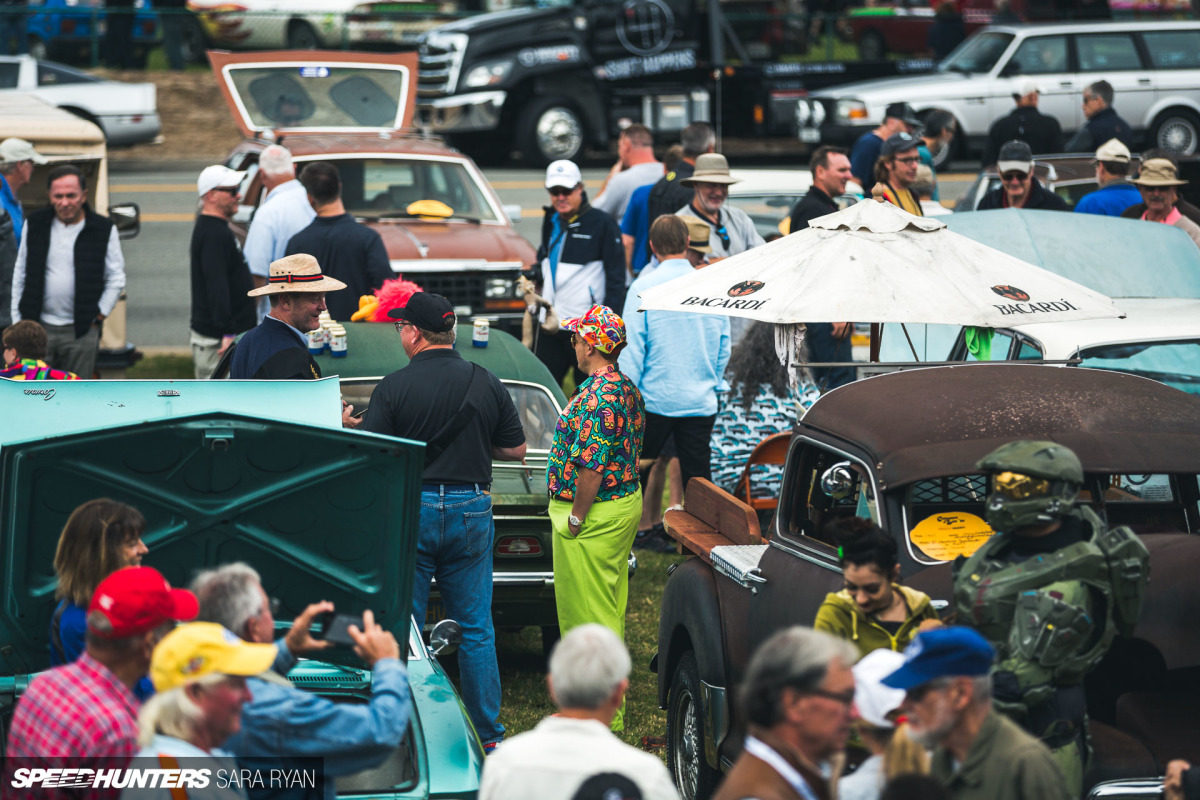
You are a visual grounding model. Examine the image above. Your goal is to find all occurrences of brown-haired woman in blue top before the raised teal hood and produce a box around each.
[50,498,152,671]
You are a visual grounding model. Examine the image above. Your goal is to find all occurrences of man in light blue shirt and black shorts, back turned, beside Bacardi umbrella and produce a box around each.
[620,216,731,496]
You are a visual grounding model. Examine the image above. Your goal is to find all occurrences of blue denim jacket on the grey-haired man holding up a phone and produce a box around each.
[224,639,413,800]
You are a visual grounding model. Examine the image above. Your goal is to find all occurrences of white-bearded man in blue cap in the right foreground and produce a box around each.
[883,627,1069,800]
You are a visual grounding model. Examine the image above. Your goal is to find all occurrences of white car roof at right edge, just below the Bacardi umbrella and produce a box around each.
[1012,297,1200,360]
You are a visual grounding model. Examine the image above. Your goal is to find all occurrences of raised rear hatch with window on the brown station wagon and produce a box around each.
[209,50,416,136]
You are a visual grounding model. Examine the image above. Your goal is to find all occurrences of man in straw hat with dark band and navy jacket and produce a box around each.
[229,253,346,380]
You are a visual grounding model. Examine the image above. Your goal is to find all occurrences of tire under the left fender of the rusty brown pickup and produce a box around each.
[667,650,721,800]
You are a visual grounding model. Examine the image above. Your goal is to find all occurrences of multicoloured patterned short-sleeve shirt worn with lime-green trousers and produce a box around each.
[546,366,646,501]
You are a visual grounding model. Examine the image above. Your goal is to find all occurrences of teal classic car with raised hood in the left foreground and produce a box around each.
[0,379,482,798]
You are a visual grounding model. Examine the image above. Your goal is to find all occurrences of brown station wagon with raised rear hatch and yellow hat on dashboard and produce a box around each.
[209,50,535,336]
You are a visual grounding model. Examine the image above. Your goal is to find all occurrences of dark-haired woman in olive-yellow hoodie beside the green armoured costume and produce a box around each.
[812,517,941,656]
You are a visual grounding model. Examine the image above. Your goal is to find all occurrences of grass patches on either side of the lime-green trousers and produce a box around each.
[496,551,683,758]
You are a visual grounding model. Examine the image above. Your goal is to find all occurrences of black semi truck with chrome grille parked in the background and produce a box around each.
[418,0,932,166]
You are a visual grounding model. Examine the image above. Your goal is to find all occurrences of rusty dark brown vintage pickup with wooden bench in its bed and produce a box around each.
[650,365,1200,800]
